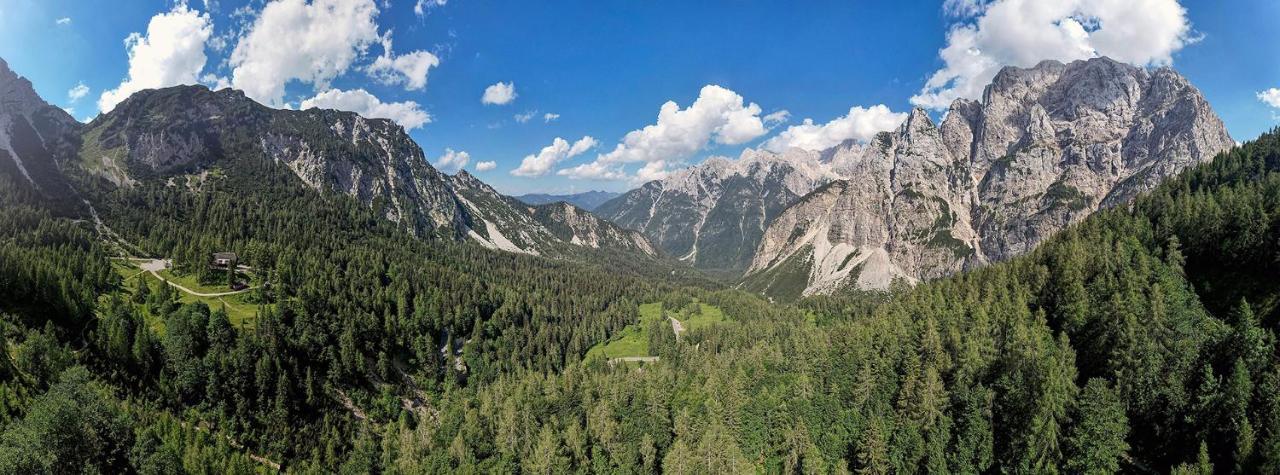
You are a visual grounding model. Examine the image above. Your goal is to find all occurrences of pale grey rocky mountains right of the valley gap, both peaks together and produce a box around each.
[598,58,1235,298]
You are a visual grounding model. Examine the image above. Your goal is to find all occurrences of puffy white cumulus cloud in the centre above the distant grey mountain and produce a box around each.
[559,85,765,179]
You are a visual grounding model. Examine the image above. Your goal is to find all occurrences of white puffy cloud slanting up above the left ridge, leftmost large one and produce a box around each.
[97,3,214,113]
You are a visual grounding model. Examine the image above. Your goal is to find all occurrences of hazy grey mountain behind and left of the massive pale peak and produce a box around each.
[595,150,838,274]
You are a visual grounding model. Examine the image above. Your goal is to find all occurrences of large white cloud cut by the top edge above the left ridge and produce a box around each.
[229,0,378,106]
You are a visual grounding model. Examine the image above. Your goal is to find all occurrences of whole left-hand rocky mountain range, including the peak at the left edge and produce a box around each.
[0,63,657,262]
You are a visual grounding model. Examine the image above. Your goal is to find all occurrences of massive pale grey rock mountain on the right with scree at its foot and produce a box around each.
[748,58,1235,294]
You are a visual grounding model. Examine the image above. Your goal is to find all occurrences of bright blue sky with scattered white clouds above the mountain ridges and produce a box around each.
[0,0,1280,193]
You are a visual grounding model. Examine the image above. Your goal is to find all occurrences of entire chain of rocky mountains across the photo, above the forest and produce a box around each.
[0,58,1235,298]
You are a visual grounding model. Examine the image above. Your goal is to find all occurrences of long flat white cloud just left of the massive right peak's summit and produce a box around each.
[764,104,906,152]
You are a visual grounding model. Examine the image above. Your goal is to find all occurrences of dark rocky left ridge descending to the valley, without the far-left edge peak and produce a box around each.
[72,86,654,256]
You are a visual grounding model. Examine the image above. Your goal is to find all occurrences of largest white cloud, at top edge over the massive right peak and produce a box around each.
[911,0,1196,109]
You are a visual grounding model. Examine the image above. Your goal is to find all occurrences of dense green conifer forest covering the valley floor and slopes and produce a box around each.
[0,131,1280,474]
